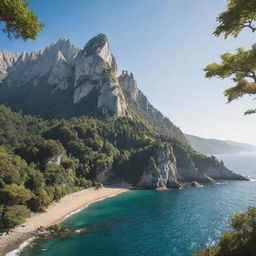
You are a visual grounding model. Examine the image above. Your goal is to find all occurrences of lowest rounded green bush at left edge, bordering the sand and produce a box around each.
[0,205,30,228]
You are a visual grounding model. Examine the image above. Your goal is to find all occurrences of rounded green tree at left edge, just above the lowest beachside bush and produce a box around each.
[0,184,31,205]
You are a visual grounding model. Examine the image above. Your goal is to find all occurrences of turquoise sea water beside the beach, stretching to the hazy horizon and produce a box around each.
[22,155,256,256]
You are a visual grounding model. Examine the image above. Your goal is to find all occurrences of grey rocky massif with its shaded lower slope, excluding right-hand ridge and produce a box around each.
[0,34,129,117]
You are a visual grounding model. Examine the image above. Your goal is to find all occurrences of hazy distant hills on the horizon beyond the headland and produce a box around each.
[185,134,256,155]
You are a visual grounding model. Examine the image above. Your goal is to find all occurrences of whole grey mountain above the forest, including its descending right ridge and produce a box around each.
[0,34,186,141]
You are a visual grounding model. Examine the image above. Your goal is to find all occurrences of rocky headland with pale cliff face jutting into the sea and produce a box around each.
[115,140,247,189]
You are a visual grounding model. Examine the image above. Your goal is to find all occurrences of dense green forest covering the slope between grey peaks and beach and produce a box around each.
[0,106,223,228]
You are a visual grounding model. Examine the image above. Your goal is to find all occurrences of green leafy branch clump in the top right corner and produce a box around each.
[214,0,256,38]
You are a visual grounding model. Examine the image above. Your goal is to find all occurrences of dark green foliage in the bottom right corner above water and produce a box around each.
[194,207,256,256]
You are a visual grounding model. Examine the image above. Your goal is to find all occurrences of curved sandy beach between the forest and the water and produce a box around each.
[0,186,129,255]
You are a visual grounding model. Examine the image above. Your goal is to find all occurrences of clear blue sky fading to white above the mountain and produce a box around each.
[0,0,256,144]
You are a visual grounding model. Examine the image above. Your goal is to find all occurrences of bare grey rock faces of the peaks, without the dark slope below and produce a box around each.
[0,34,129,116]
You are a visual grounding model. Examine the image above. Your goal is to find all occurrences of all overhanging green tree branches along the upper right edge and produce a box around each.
[204,0,256,114]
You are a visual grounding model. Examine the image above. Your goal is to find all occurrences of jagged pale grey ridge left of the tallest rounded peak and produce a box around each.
[6,39,79,89]
